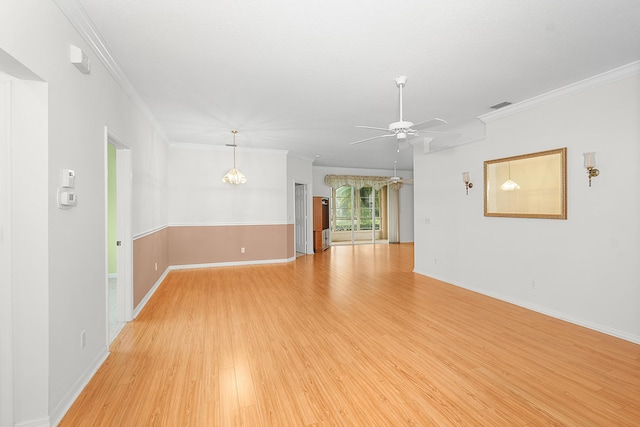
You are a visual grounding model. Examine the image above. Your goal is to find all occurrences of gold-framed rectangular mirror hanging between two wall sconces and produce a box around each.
[484,147,567,219]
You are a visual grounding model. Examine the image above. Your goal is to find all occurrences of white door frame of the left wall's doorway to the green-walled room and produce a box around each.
[104,126,133,334]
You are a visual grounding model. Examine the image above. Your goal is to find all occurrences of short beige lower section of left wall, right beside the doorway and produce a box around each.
[133,228,170,308]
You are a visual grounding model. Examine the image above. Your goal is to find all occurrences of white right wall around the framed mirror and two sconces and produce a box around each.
[414,63,640,342]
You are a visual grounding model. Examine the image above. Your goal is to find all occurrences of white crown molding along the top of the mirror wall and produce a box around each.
[478,61,640,123]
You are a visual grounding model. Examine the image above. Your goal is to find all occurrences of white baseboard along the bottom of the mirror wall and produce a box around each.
[413,270,640,344]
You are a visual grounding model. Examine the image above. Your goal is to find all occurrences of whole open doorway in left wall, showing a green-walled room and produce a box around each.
[105,127,133,345]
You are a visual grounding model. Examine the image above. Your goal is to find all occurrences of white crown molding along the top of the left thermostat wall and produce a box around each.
[53,0,168,141]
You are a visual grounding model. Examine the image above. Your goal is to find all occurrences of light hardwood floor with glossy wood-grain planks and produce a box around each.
[60,244,640,426]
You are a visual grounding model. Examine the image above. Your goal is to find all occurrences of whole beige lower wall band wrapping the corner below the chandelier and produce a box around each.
[133,224,295,307]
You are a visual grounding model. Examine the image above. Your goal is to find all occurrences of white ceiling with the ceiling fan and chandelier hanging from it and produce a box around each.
[61,0,640,170]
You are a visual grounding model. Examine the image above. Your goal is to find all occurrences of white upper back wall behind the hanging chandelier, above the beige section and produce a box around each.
[169,144,288,225]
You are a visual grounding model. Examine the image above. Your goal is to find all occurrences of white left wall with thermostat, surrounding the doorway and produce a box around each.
[0,0,167,425]
